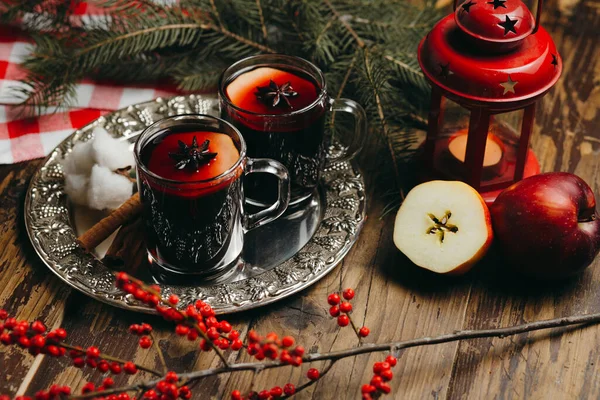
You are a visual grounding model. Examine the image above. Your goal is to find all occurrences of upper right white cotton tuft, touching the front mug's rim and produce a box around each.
[92,127,135,171]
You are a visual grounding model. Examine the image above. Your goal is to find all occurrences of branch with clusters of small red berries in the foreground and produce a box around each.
[0,273,600,400]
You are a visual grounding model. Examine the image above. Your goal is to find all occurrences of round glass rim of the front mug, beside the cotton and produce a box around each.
[133,114,246,189]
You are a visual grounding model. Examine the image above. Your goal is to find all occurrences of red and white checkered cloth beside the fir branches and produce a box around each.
[0,3,177,164]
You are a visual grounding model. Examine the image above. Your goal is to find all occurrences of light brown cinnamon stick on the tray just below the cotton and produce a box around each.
[77,193,142,251]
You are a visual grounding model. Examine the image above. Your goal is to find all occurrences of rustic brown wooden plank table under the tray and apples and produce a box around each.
[0,0,600,399]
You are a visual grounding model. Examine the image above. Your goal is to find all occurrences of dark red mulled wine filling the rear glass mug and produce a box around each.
[221,66,328,204]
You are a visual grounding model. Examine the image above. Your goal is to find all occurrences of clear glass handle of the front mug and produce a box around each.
[244,158,290,231]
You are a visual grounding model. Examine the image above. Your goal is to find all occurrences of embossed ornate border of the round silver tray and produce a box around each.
[25,95,366,314]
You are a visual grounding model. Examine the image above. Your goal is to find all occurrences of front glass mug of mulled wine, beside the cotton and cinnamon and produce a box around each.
[134,115,290,280]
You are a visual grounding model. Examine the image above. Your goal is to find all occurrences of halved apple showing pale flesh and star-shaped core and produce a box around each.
[394,181,494,275]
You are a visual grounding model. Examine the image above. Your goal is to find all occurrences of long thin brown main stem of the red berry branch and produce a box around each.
[70,313,600,399]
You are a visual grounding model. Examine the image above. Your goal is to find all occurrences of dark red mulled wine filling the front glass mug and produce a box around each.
[140,128,243,273]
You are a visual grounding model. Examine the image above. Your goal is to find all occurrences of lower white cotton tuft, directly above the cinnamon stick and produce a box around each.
[88,165,133,210]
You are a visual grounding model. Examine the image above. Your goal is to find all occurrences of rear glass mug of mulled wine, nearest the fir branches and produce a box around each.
[219,54,367,206]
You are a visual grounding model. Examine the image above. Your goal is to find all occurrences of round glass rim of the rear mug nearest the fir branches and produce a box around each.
[219,54,327,118]
